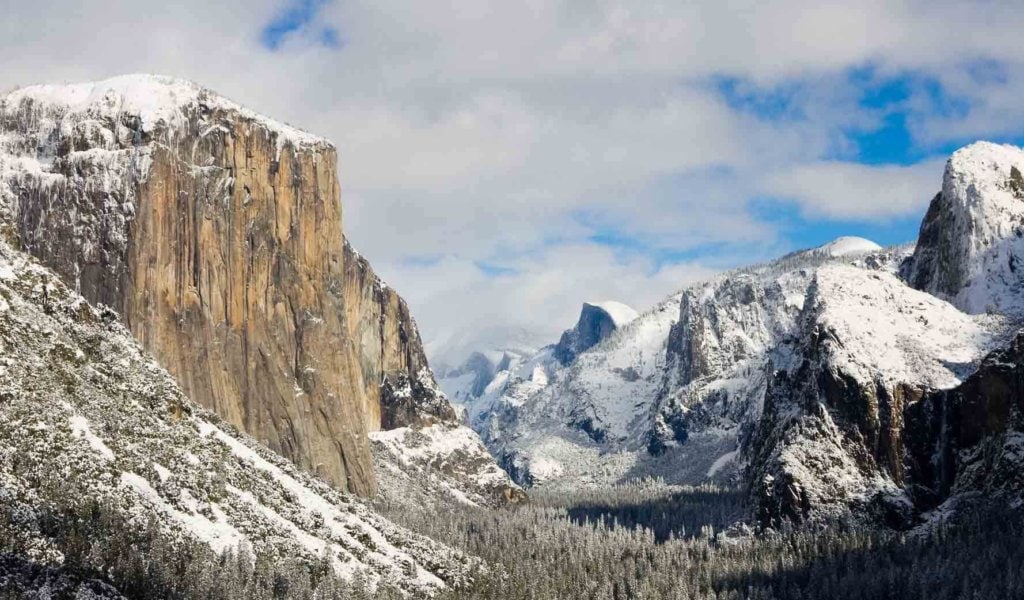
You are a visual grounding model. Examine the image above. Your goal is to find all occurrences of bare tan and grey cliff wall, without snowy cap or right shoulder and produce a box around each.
[7,101,379,495]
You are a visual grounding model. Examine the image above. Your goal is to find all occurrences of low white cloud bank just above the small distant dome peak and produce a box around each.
[376,244,715,362]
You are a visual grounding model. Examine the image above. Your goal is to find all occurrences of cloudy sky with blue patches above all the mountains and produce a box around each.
[0,0,1024,363]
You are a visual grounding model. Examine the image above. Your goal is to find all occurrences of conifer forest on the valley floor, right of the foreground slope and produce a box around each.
[383,485,1024,600]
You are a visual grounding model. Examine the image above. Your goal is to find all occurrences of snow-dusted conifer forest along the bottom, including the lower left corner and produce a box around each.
[0,484,1024,600]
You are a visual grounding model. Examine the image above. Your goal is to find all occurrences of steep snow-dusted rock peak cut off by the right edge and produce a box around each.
[904,142,1024,315]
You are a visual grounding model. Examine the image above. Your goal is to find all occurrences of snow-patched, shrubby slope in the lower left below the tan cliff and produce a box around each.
[0,235,467,591]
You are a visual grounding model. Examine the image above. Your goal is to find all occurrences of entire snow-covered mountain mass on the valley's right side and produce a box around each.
[462,142,1024,526]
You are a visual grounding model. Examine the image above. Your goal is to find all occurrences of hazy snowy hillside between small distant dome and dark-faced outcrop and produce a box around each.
[470,233,901,484]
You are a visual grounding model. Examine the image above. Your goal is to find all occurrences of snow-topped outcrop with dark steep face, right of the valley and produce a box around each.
[744,266,1002,526]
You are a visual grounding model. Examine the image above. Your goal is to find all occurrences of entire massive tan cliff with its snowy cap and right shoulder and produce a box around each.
[0,76,454,495]
